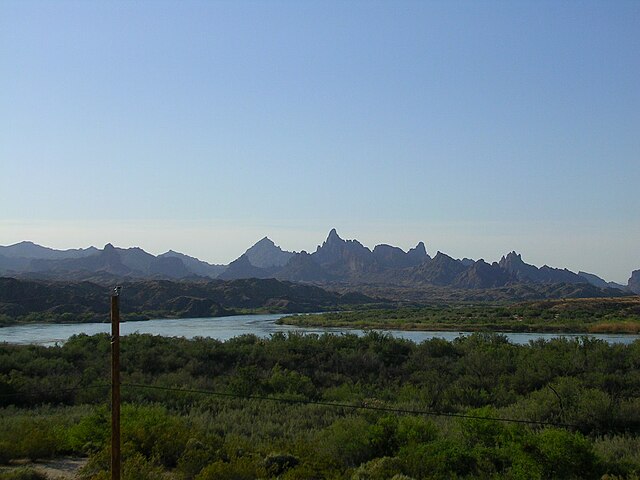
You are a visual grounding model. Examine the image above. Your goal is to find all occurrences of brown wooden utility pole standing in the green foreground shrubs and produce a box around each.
[111,287,122,480]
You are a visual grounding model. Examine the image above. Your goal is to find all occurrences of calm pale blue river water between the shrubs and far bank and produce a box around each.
[0,315,640,345]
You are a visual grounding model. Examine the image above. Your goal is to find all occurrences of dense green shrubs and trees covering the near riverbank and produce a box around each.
[0,333,640,480]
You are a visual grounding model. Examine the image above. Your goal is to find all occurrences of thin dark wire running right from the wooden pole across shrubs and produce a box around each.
[121,383,578,428]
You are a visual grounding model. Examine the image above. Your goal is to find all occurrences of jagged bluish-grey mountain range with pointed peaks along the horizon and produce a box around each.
[0,229,640,295]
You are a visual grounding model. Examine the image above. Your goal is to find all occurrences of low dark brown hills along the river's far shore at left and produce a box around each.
[0,278,378,322]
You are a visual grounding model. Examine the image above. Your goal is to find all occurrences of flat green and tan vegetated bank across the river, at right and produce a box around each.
[277,297,640,335]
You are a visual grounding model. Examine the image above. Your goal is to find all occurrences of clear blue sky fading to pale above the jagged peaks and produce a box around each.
[0,0,640,284]
